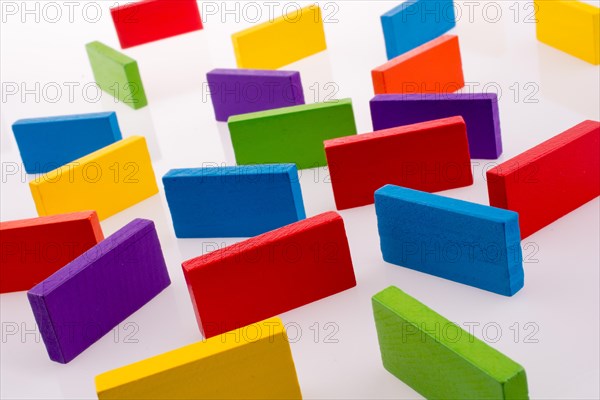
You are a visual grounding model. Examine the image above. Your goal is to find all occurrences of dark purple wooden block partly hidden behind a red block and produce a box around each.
[371,93,502,160]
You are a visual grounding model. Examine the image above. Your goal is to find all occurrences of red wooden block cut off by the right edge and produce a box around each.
[486,121,600,239]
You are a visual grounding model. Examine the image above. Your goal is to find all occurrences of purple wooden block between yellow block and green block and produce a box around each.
[206,69,304,121]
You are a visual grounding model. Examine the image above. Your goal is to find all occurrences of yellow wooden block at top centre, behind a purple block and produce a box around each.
[231,4,327,69]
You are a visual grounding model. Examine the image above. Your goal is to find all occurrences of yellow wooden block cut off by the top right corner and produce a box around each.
[534,0,600,65]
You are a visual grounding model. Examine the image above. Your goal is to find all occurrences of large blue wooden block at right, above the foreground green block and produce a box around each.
[375,185,524,296]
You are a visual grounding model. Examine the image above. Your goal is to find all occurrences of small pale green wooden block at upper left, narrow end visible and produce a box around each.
[85,42,148,110]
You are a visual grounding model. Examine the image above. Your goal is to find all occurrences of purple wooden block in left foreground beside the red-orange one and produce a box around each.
[27,219,171,364]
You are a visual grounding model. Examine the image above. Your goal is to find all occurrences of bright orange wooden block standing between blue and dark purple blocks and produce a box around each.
[371,35,465,94]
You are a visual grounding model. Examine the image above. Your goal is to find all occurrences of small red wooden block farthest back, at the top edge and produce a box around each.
[110,0,202,49]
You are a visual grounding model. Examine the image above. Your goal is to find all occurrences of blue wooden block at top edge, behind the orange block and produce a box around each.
[381,0,456,60]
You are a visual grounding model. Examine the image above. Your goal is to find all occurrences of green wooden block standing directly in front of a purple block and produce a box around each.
[227,99,356,169]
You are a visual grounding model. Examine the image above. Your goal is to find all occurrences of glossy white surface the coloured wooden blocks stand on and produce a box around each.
[0,1,600,399]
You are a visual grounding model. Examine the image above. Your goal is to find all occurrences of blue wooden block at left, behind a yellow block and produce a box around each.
[12,112,122,174]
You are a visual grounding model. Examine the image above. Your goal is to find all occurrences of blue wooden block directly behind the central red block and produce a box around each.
[163,164,306,238]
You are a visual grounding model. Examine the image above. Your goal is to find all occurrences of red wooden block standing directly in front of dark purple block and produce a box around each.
[325,117,473,210]
